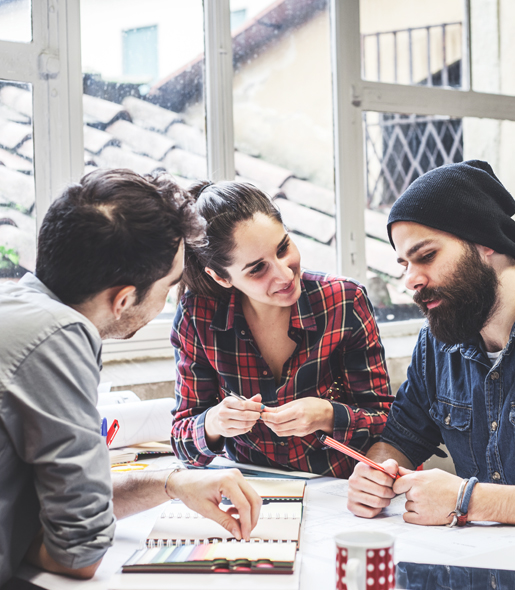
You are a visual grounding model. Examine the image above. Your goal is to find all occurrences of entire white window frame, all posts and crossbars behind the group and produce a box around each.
[6,0,515,360]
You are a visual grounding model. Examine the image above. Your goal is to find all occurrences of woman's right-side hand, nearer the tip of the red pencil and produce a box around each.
[261,397,334,436]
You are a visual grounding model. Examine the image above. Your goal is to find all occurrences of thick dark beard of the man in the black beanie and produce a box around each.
[413,243,499,345]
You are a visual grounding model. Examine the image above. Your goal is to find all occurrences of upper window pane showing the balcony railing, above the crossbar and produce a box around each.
[360,0,464,88]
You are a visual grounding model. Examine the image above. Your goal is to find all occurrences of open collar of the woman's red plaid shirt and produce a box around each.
[210,279,317,332]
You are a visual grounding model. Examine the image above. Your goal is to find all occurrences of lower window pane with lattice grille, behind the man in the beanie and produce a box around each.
[363,112,515,321]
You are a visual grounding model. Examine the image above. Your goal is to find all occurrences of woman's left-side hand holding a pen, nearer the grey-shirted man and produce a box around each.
[204,393,263,447]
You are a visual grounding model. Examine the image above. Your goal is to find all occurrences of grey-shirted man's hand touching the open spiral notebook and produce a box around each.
[169,469,262,541]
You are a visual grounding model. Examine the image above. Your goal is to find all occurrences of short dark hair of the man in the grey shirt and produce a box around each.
[36,169,203,305]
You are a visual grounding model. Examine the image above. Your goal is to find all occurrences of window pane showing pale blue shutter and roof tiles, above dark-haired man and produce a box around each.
[81,0,207,320]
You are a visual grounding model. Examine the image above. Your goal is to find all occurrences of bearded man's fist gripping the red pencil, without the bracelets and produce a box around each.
[347,459,402,518]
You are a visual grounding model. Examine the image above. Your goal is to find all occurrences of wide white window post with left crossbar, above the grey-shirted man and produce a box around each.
[0,0,84,230]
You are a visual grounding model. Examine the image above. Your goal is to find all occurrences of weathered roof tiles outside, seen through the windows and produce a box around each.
[0,86,410,312]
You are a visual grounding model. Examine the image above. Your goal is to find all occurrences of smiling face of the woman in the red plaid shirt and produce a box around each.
[209,213,301,307]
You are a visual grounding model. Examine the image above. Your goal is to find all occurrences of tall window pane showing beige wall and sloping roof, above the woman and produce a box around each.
[231,0,336,280]
